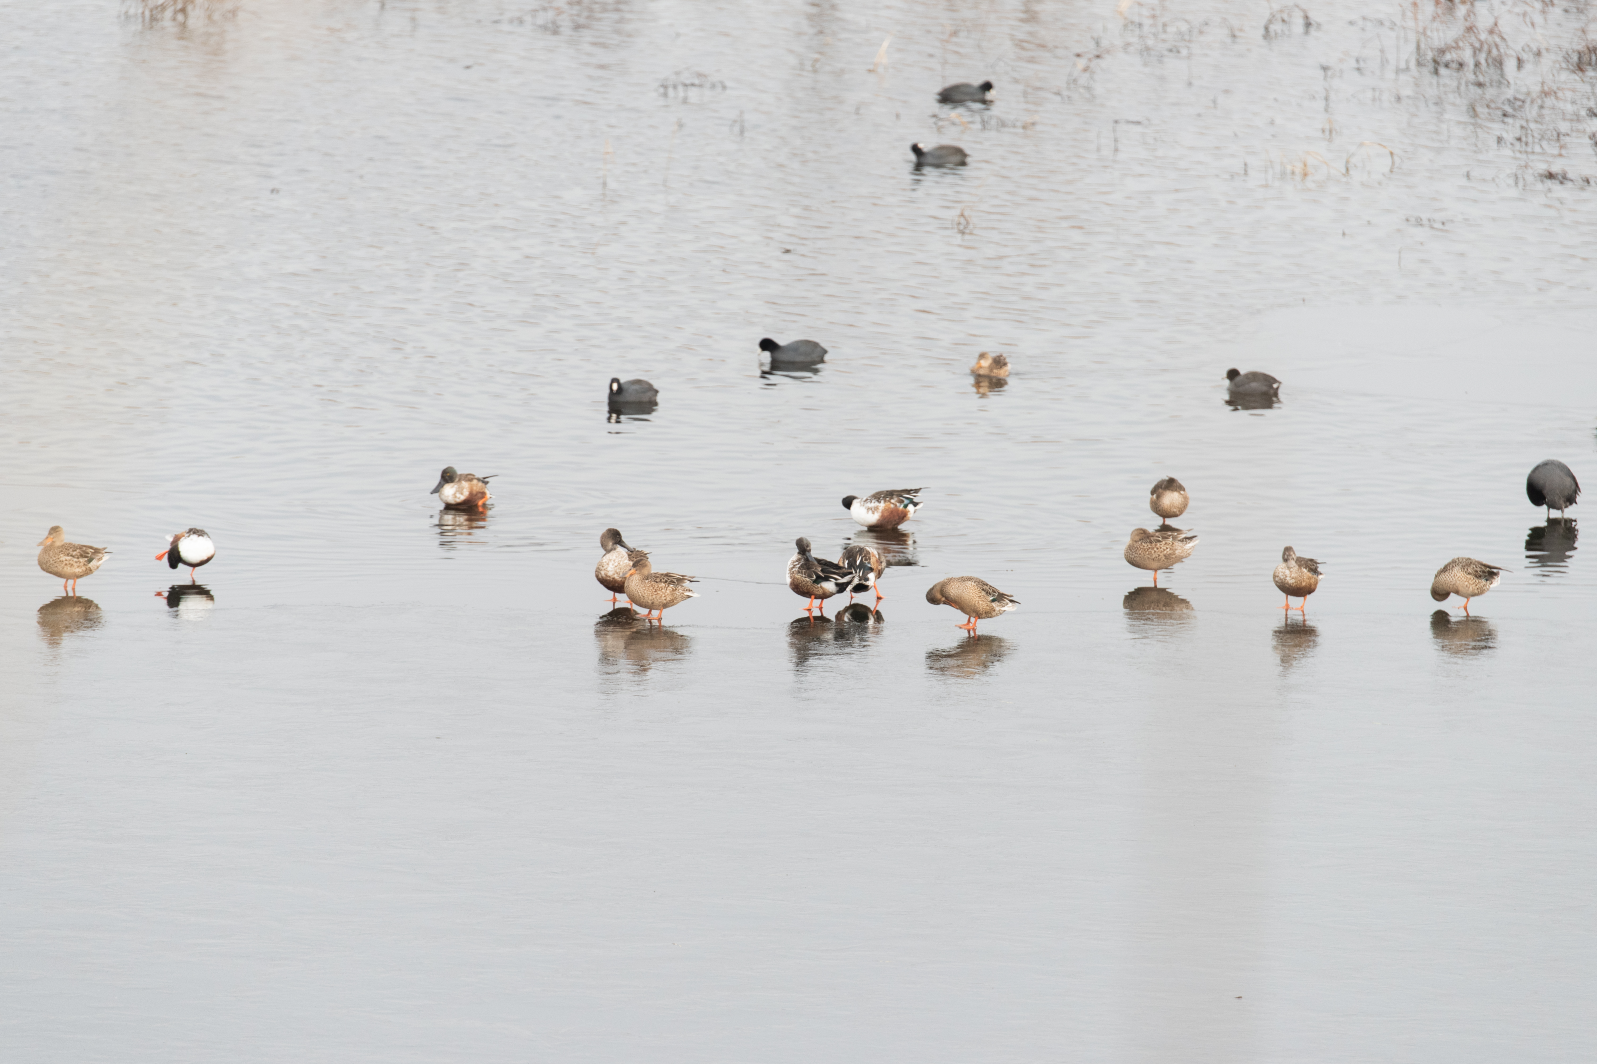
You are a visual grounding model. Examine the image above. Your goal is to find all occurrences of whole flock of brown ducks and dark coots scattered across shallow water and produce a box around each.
[24,81,1581,636]
